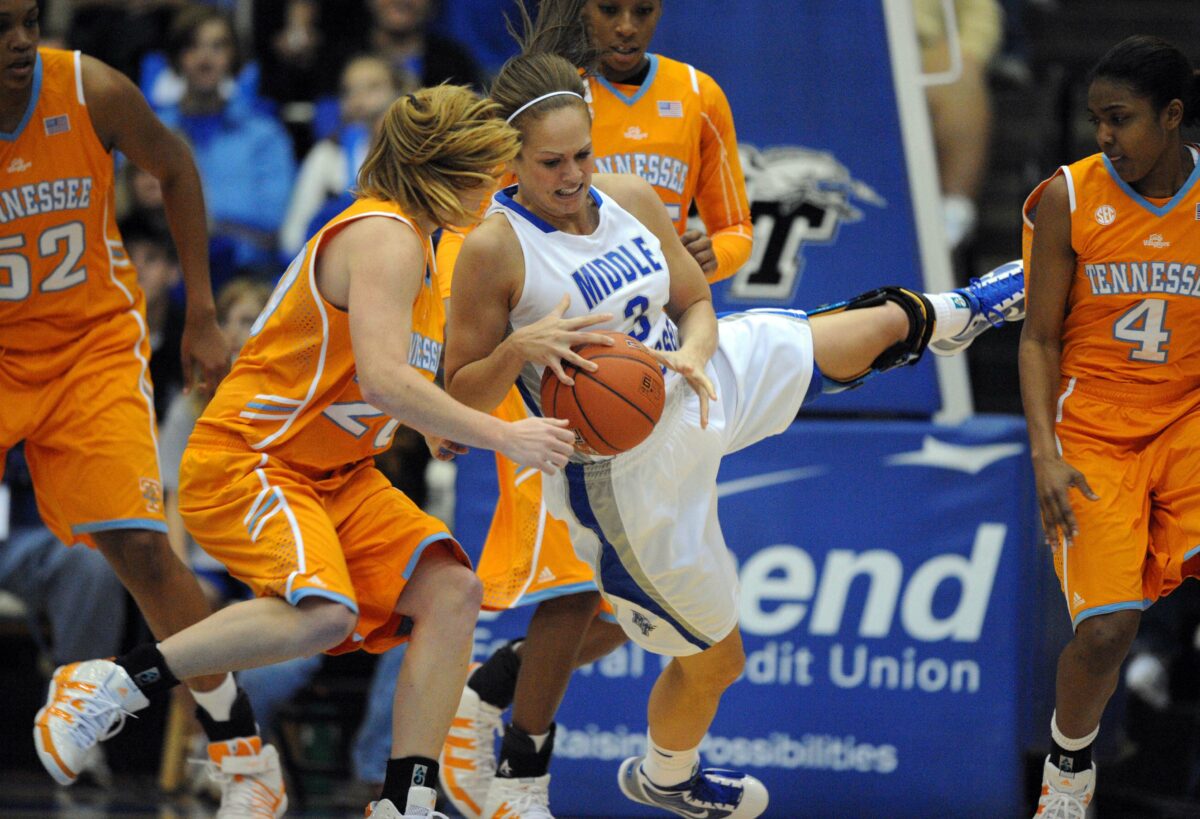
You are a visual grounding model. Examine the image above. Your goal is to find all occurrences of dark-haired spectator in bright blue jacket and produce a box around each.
[160,6,295,278]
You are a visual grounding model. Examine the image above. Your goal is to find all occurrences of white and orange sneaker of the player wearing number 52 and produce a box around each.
[209,736,288,819]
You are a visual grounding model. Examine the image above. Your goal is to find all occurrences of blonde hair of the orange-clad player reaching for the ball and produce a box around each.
[356,85,520,226]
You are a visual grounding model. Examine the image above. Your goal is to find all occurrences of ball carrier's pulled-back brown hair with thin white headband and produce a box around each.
[491,0,599,128]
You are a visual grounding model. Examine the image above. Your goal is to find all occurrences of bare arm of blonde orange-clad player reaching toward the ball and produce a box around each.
[331,216,575,473]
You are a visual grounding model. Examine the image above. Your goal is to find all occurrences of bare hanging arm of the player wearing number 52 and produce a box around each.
[82,56,229,390]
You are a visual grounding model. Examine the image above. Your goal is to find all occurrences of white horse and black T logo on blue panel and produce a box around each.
[728,143,888,301]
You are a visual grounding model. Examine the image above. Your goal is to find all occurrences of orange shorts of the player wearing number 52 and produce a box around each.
[0,309,167,546]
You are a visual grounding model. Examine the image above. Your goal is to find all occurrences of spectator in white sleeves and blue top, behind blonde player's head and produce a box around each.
[280,54,415,258]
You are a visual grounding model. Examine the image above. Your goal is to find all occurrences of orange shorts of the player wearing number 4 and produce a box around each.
[1055,378,1200,626]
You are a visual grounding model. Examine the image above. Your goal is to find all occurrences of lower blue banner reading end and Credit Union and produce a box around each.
[457,417,1045,819]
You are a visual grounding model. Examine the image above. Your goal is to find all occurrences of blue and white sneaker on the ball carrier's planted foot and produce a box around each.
[617,757,768,819]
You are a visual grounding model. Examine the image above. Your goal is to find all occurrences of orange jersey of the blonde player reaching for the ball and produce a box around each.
[197,199,445,473]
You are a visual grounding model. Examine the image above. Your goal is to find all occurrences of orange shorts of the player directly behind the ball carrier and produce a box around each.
[478,389,612,616]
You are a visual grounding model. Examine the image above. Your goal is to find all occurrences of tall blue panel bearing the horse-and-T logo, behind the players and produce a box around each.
[652,0,968,417]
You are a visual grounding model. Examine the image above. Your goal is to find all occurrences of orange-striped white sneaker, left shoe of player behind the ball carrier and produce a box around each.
[438,686,503,819]
